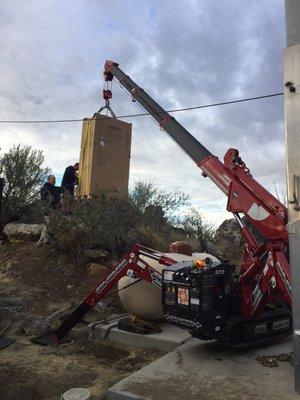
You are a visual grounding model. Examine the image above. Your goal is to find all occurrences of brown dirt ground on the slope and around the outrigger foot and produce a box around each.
[0,242,160,400]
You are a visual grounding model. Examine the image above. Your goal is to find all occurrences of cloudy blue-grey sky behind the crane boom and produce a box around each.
[0,0,285,225]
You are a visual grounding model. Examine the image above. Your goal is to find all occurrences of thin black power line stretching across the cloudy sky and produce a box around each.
[0,92,283,124]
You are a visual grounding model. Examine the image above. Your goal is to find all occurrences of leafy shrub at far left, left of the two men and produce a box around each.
[0,145,50,223]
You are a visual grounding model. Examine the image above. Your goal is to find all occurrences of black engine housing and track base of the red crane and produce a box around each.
[162,258,292,346]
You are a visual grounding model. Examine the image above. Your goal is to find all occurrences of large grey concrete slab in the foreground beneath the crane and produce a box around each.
[107,339,300,400]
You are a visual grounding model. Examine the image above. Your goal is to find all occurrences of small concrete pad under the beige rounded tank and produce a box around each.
[89,321,191,353]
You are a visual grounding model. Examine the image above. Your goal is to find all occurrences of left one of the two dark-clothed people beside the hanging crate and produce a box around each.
[36,175,63,246]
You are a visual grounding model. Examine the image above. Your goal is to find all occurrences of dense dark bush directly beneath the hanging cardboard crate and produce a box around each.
[49,198,149,258]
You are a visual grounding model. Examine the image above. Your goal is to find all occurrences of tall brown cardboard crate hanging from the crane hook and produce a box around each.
[78,113,132,198]
